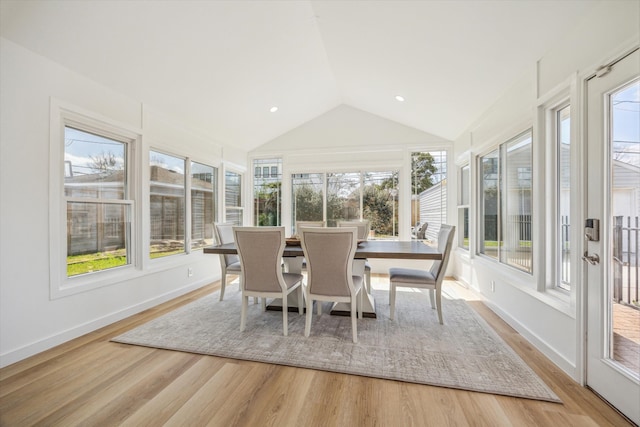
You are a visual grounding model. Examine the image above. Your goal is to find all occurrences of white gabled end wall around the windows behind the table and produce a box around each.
[250,105,452,242]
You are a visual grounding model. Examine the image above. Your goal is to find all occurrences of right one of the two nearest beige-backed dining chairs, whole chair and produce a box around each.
[300,227,364,343]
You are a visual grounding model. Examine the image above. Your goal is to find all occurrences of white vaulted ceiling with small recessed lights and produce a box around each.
[0,0,599,150]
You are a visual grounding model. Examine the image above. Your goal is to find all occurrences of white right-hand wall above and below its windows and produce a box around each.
[453,1,640,381]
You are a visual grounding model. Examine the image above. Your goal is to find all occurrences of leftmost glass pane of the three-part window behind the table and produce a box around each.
[291,173,324,234]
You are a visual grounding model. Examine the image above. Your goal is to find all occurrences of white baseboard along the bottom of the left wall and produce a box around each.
[0,278,212,368]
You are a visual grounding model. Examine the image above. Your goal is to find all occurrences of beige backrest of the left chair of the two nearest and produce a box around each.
[233,227,286,292]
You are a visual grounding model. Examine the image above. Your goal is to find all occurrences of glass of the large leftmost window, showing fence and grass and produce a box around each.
[64,126,131,277]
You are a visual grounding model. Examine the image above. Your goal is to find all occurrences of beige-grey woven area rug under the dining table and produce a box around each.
[112,290,560,402]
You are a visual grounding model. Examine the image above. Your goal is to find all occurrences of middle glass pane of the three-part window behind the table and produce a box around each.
[327,172,360,227]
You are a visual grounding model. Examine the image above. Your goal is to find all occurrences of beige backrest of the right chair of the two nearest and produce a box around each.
[300,227,358,297]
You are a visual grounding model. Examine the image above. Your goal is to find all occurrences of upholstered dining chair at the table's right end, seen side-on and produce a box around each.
[389,224,456,325]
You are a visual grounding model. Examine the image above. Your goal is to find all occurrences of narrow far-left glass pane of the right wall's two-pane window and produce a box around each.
[479,150,500,259]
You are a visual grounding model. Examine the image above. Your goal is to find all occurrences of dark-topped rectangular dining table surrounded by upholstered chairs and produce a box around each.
[203,238,443,318]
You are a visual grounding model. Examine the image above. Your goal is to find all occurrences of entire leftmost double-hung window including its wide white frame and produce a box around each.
[49,99,141,298]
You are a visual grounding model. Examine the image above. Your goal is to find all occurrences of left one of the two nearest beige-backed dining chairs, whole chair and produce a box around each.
[233,227,304,336]
